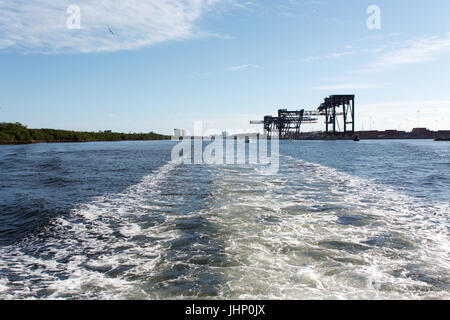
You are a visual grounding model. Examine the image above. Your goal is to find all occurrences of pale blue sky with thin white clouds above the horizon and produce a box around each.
[0,0,450,134]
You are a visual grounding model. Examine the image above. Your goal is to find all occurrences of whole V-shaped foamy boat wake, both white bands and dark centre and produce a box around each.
[0,156,450,299]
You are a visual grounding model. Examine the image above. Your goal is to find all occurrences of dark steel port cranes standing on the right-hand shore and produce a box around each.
[250,95,355,139]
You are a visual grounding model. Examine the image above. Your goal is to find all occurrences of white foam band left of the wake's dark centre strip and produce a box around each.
[0,162,177,299]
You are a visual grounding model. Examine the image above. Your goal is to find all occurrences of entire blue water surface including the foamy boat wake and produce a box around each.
[0,140,450,299]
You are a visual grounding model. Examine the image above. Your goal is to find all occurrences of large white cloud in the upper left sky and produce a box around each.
[0,0,226,53]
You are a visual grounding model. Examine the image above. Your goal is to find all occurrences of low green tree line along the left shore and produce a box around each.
[0,122,170,143]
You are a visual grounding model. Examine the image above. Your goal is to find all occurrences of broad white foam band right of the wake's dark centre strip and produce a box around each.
[211,157,450,299]
